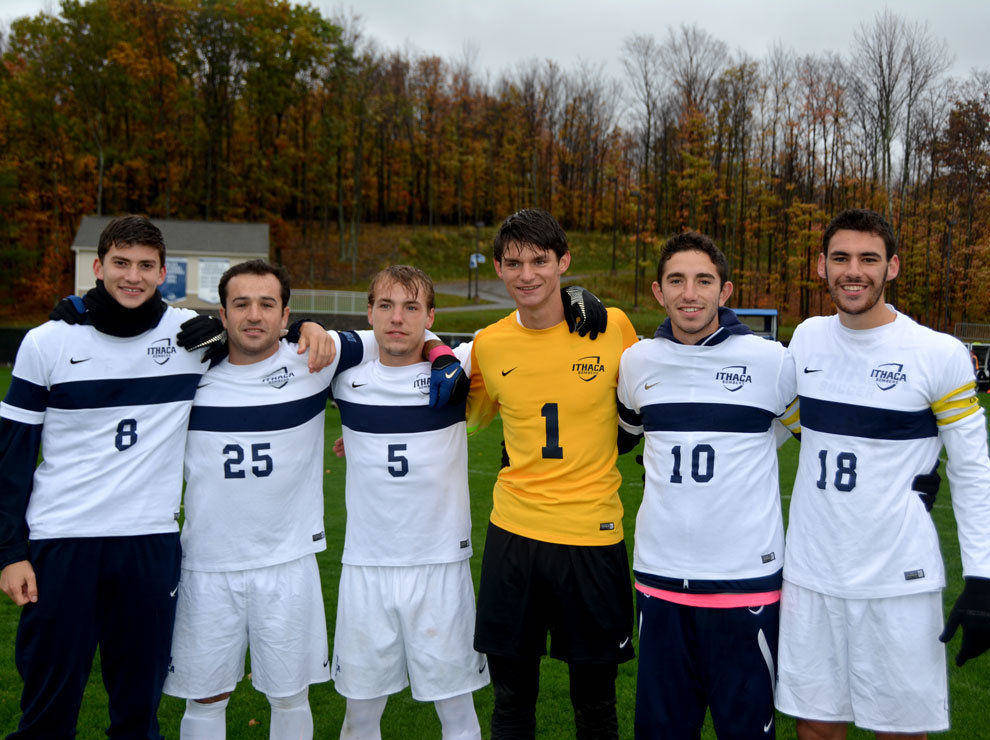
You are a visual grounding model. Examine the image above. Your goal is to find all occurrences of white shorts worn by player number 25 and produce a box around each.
[164,555,330,699]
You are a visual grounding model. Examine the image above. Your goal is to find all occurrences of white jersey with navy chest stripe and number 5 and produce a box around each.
[333,344,471,565]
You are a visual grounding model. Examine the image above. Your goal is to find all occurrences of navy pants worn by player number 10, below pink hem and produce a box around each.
[636,591,780,740]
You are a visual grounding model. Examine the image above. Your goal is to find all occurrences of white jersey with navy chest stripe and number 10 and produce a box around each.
[617,334,795,591]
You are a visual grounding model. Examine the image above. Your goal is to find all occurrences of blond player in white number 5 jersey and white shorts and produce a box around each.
[331,265,488,740]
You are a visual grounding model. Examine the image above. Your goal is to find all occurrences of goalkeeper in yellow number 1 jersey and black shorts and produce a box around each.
[468,209,636,738]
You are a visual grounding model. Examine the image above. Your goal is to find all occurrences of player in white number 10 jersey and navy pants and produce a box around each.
[618,232,797,739]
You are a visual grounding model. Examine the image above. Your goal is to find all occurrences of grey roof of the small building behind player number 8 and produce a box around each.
[72,216,268,257]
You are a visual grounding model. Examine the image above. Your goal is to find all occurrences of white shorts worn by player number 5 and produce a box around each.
[330,560,488,701]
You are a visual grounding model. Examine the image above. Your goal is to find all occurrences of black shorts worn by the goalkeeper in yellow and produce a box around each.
[474,523,633,663]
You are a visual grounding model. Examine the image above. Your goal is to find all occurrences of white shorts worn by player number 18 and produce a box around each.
[776,581,949,733]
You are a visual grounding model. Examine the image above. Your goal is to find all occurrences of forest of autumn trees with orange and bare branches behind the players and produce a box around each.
[0,0,990,323]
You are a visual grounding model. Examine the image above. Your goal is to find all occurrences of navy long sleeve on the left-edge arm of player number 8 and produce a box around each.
[0,419,41,568]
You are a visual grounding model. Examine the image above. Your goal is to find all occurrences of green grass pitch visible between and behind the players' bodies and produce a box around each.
[0,369,990,740]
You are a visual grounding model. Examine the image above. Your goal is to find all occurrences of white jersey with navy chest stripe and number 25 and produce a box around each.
[182,332,372,571]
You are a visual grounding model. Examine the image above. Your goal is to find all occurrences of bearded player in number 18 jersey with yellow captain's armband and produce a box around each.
[776,210,990,740]
